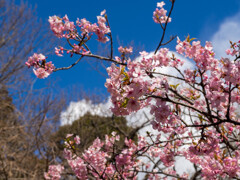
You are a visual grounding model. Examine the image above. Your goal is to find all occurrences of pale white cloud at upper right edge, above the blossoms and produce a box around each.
[211,13,240,58]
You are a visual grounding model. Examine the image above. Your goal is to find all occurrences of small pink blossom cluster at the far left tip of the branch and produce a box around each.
[25,53,55,79]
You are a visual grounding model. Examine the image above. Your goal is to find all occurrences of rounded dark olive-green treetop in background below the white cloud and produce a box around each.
[52,113,137,152]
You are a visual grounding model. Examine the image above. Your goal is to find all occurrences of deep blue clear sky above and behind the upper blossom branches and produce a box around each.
[28,0,240,97]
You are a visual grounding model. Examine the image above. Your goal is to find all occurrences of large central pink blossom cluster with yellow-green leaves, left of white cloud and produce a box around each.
[105,48,183,118]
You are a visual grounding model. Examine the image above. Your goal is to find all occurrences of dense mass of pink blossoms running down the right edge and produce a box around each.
[173,37,240,179]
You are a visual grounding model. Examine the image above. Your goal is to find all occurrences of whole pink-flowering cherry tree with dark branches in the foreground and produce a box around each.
[26,1,240,179]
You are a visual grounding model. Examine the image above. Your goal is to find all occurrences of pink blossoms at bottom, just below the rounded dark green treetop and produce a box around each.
[64,132,142,179]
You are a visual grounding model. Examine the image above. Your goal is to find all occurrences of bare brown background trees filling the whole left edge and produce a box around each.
[0,0,64,179]
